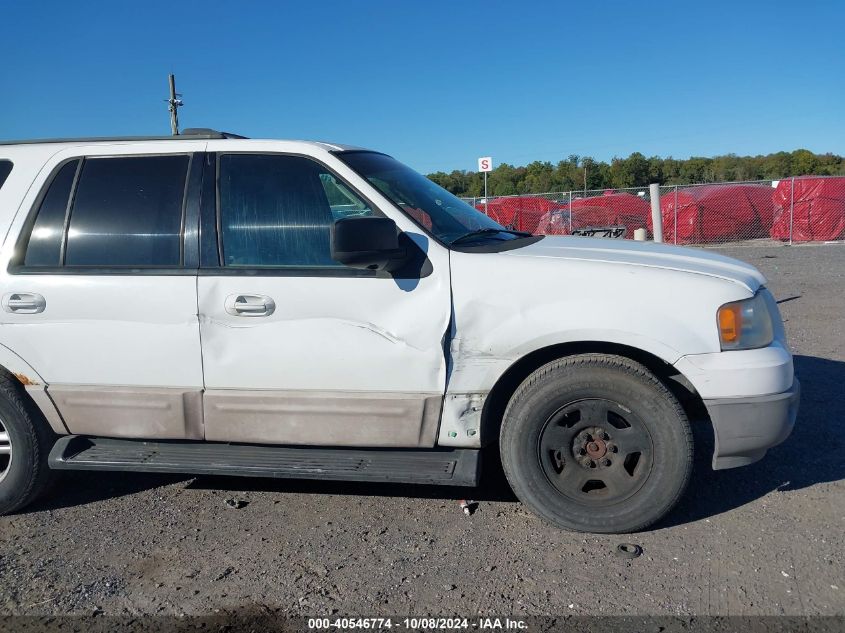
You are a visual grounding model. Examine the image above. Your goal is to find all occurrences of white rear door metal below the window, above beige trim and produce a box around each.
[0,275,202,389]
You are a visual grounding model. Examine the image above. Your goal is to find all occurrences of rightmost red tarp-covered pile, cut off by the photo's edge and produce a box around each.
[771,176,845,242]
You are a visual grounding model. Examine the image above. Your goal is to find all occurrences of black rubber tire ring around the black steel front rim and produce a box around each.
[501,362,692,532]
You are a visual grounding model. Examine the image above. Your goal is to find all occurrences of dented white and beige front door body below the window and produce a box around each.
[199,262,450,446]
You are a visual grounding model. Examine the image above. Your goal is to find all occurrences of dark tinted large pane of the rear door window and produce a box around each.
[65,156,188,267]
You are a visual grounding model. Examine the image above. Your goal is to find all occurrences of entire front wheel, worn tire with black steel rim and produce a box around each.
[500,354,693,533]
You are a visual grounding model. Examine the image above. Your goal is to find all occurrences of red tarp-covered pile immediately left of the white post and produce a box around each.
[535,191,651,238]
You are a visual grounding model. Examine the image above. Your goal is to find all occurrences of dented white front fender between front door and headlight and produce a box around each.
[447,253,751,393]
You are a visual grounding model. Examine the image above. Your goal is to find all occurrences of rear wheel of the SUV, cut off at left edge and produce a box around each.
[0,376,56,516]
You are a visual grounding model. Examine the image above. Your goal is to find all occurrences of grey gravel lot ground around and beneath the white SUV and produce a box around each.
[0,245,845,616]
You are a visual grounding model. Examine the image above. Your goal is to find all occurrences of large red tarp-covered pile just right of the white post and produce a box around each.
[648,184,774,244]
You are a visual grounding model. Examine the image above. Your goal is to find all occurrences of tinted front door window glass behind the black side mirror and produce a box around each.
[219,154,372,267]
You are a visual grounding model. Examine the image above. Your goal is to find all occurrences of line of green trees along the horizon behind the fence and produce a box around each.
[428,149,845,197]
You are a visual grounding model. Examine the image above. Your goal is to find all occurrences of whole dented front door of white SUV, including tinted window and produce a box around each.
[198,153,450,447]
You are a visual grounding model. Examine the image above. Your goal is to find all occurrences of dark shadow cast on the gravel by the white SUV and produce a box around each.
[19,356,845,528]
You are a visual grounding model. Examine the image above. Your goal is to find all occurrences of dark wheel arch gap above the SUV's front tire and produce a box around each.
[481,341,709,445]
